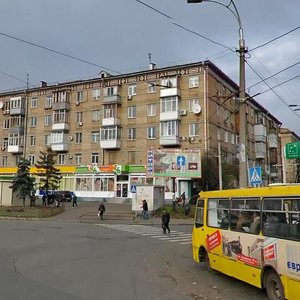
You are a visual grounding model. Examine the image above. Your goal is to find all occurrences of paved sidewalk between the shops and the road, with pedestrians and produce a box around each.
[48,202,193,225]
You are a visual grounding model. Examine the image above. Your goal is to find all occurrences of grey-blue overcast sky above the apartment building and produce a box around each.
[0,0,300,135]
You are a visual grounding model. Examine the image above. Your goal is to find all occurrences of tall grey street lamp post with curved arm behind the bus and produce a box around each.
[187,0,248,188]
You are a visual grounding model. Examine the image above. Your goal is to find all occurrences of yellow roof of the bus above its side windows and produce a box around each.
[200,184,300,198]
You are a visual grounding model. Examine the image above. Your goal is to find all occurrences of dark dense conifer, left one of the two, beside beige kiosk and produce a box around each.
[10,157,34,206]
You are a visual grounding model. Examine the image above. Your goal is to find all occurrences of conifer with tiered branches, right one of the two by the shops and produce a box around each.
[35,148,61,205]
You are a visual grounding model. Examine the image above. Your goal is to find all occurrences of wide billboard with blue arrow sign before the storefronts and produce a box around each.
[147,149,201,177]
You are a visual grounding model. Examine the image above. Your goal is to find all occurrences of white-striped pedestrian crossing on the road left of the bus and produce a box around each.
[96,224,192,245]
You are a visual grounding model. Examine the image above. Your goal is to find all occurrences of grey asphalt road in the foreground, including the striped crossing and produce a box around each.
[0,220,266,300]
